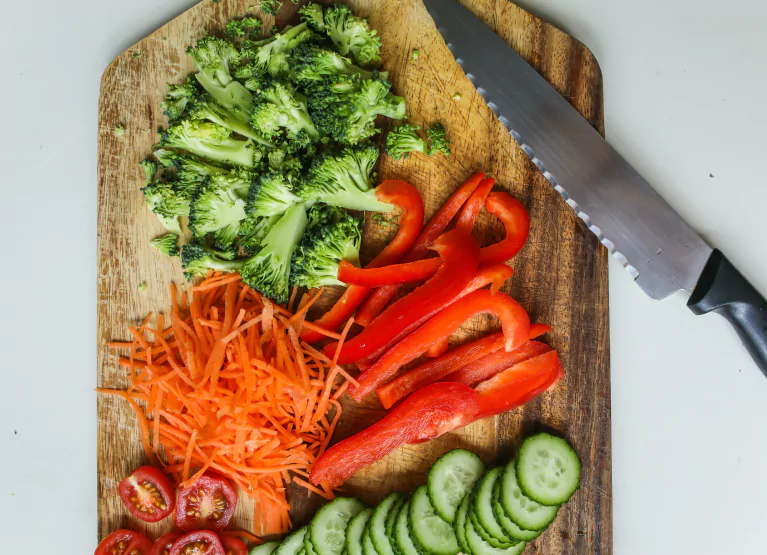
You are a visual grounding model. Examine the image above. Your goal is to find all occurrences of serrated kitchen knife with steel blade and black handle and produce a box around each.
[424,0,767,376]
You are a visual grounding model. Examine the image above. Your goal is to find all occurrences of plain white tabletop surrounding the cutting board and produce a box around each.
[0,0,767,555]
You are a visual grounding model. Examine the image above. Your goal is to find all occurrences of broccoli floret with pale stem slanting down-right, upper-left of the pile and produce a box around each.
[186,37,253,113]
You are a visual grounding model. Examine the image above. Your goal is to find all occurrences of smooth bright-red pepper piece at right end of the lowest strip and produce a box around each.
[474,351,565,420]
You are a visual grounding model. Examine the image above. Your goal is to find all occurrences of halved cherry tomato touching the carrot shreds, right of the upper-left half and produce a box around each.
[176,472,237,530]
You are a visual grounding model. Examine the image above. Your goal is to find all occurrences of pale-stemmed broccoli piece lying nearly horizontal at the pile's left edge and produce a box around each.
[160,120,262,168]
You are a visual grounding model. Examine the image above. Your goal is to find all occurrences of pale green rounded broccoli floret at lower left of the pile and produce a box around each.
[189,176,245,249]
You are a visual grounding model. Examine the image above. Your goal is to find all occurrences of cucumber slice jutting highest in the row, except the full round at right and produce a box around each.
[427,449,485,522]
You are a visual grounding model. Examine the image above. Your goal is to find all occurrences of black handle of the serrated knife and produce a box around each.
[687,249,767,376]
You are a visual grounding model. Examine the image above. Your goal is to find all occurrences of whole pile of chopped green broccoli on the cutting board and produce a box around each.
[137,0,428,302]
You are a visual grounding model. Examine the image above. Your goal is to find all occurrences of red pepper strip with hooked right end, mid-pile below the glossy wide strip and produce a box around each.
[348,290,530,402]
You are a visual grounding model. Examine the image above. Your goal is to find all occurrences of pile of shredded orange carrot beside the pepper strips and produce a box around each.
[98,274,354,535]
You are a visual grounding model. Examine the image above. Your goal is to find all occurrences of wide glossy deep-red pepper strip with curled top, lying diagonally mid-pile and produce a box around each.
[325,230,479,364]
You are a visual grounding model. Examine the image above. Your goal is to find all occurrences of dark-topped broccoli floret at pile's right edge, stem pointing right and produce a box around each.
[309,75,405,144]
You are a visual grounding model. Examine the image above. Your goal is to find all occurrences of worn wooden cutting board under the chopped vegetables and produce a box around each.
[98,0,612,555]
